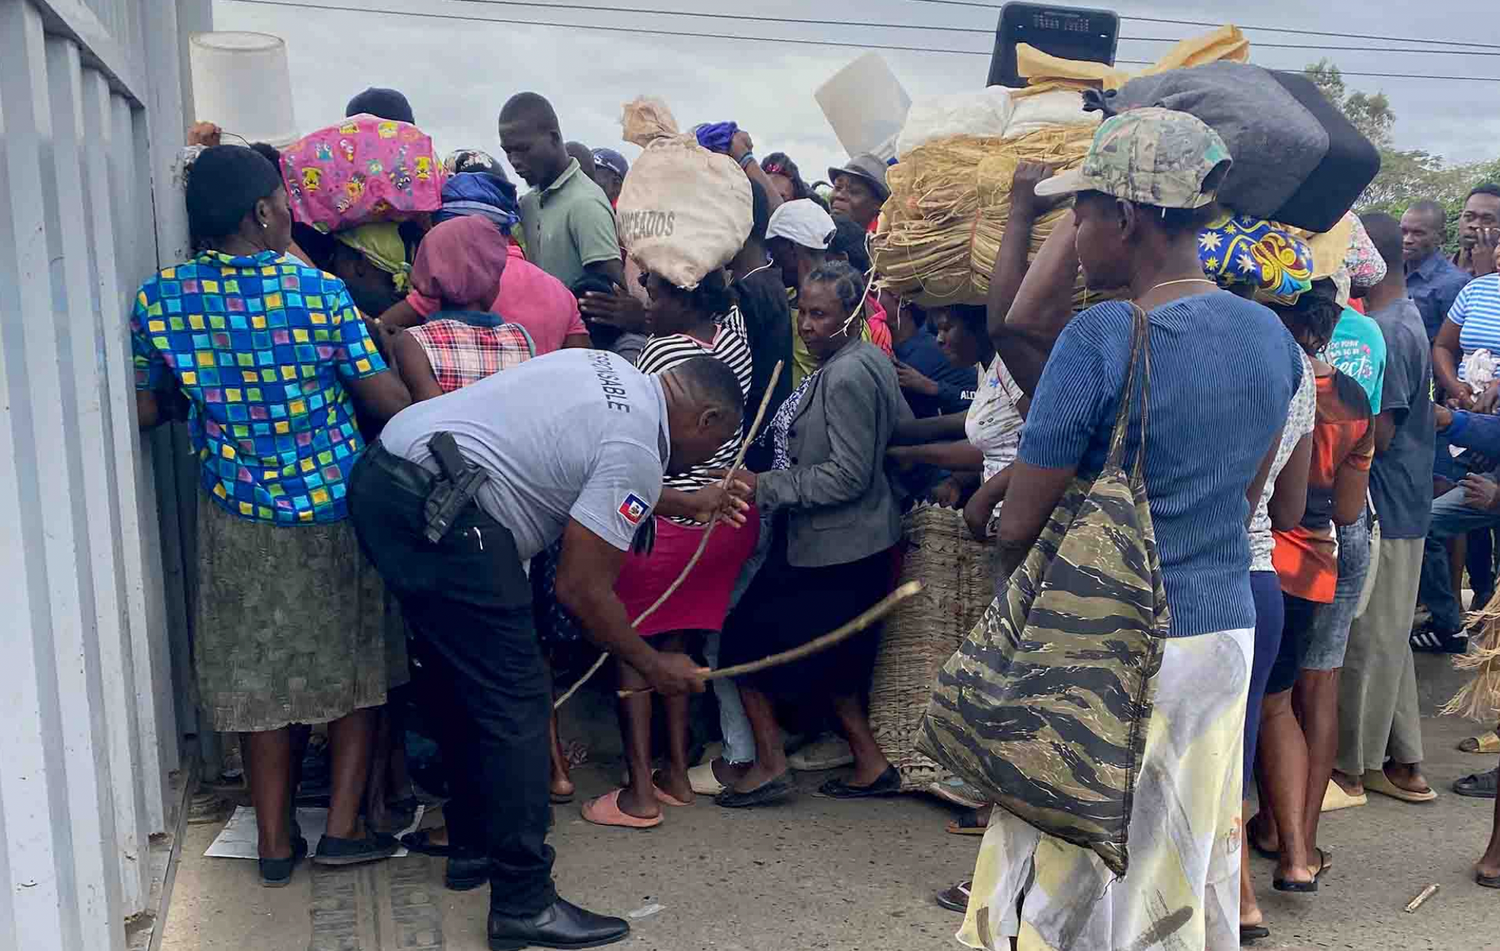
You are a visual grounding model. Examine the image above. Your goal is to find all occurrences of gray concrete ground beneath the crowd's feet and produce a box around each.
[161,657,1500,951]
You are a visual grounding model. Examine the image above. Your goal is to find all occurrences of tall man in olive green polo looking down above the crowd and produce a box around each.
[500,93,624,288]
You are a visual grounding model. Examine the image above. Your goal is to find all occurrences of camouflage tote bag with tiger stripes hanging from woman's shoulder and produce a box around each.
[918,305,1170,876]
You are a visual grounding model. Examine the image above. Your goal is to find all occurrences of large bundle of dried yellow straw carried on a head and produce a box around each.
[872,126,1094,306]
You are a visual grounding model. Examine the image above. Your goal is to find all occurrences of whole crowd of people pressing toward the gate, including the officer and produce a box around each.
[131,81,1500,950]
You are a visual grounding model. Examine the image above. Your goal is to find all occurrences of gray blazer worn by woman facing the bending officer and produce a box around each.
[756,342,912,569]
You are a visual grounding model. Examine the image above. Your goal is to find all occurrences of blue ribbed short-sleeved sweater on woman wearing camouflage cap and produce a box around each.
[1020,291,1302,638]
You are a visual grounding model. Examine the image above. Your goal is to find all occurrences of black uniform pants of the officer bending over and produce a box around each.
[348,443,557,917]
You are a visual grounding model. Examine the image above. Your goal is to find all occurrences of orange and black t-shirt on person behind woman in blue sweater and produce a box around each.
[1271,371,1376,605]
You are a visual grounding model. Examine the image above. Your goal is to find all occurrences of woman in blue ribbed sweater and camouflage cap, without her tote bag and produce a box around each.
[960,108,1302,951]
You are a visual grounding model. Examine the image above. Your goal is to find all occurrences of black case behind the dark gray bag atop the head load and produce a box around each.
[1271,71,1380,233]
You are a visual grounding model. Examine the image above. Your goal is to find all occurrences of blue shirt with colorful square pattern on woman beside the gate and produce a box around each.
[131,251,386,525]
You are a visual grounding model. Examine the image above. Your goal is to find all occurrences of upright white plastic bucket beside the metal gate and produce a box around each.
[188,32,302,149]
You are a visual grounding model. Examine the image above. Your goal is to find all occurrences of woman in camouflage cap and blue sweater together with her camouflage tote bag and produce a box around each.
[929,108,1302,951]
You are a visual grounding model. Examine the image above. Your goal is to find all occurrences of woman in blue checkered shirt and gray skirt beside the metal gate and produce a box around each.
[131,146,411,885]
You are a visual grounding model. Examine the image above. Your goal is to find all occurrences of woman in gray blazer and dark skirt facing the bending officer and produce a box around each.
[719,263,911,807]
